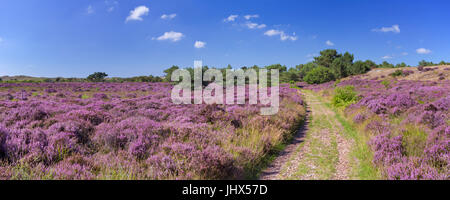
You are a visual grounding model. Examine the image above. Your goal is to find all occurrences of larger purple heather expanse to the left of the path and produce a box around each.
[0,83,306,179]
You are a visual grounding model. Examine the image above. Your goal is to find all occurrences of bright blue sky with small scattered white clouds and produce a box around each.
[0,0,450,77]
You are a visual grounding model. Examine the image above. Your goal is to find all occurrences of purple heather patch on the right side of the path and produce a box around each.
[309,69,450,180]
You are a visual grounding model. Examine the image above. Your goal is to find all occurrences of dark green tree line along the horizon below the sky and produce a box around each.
[0,49,450,84]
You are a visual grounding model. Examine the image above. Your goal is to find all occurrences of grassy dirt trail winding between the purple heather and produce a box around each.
[260,91,352,180]
